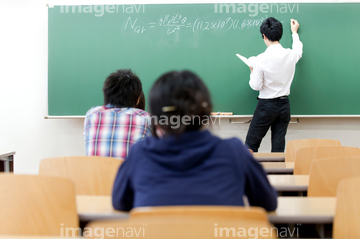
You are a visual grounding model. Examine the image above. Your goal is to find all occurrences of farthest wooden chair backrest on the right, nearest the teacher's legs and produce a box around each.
[285,139,341,162]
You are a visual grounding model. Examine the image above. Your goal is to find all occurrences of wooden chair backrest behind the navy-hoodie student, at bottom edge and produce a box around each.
[85,206,277,239]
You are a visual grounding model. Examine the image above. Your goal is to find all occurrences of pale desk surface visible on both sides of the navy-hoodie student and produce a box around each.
[76,196,336,224]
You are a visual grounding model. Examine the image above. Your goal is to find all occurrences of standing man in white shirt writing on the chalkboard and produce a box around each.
[245,17,303,152]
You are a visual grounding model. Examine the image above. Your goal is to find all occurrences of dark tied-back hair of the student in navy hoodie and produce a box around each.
[149,70,212,137]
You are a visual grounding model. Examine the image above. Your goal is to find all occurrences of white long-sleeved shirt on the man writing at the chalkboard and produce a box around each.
[249,33,303,99]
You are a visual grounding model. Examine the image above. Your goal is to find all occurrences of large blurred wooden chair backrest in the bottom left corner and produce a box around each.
[0,174,79,236]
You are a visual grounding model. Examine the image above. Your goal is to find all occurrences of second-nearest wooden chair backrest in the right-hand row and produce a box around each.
[308,156,360,197]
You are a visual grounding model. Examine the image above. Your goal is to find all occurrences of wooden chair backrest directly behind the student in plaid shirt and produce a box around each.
[39,156,123,195]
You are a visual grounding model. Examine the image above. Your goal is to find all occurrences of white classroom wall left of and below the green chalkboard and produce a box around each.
[0,0,360,174]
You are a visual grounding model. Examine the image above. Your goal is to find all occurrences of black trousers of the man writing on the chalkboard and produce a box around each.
[245,96,291,152]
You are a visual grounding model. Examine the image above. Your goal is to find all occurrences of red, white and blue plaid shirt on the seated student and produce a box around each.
[84,105,151,159]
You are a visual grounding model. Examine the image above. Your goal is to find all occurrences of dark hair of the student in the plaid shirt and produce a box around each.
[103,69,142,108]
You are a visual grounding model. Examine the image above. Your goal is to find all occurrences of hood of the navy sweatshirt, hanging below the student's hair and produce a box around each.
[142,130,221,171]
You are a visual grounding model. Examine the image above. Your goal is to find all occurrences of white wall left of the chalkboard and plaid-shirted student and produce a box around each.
[0,0,84,173]
